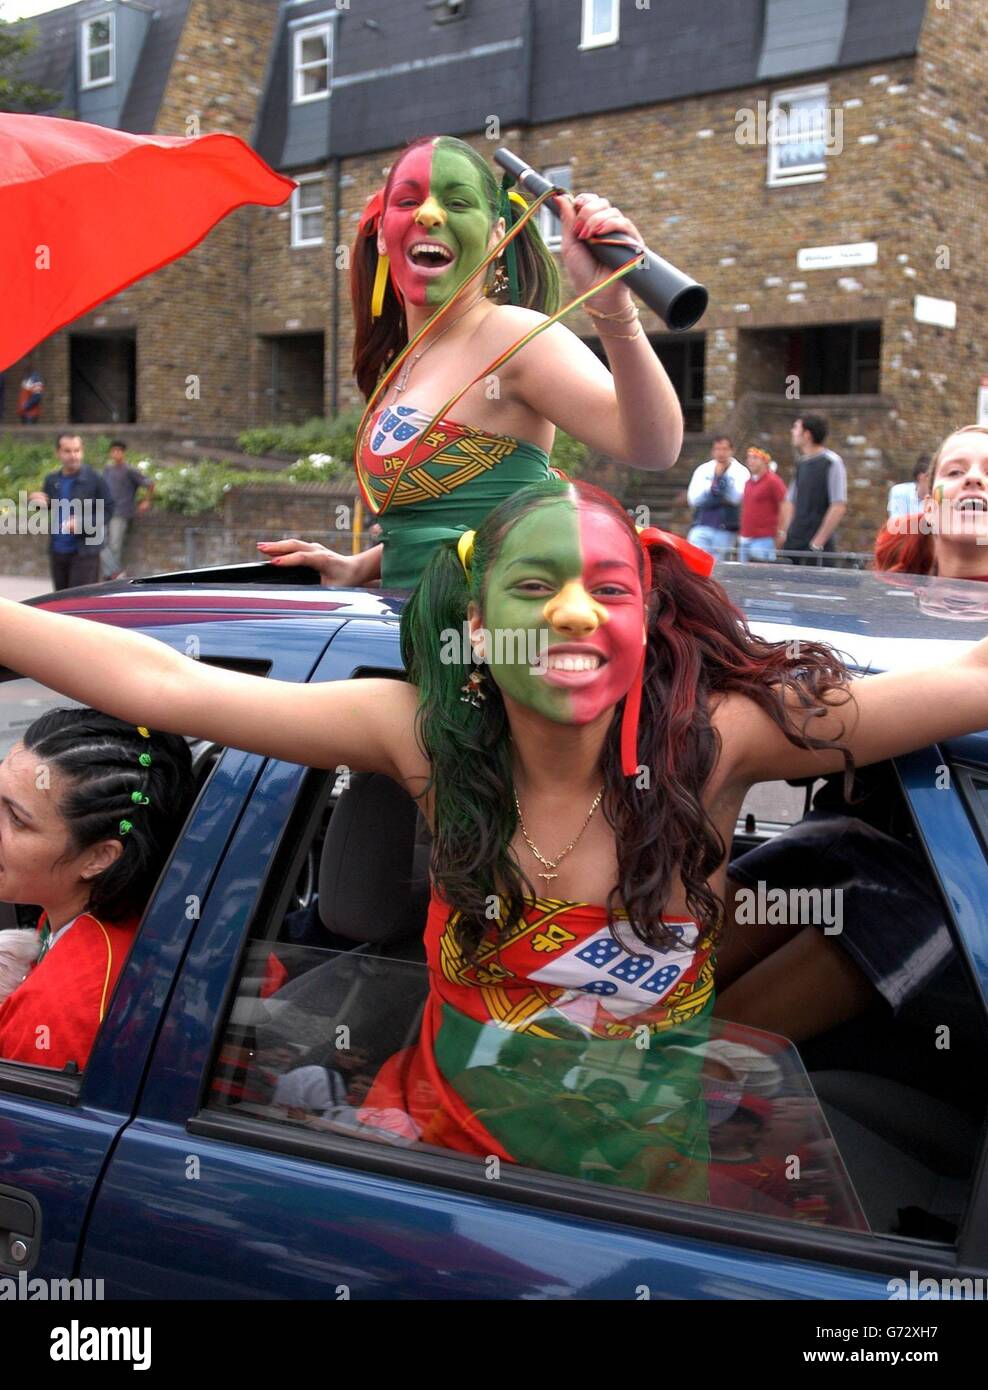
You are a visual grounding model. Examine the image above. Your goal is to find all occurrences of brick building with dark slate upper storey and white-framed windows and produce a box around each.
[7,0,988,545]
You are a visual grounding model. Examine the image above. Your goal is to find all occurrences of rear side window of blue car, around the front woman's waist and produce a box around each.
[207,774,985,1243]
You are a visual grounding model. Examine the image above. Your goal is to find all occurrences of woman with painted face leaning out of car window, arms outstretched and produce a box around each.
[0,481,988,1200]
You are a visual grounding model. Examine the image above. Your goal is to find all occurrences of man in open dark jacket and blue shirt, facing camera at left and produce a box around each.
[29,432,113,589]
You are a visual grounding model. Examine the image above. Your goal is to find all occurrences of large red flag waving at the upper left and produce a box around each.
[0,111,295,371]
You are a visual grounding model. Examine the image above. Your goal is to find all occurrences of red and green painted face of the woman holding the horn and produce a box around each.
[381,136,493,304]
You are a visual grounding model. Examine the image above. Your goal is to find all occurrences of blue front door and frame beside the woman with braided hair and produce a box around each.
[0,613,340,1277]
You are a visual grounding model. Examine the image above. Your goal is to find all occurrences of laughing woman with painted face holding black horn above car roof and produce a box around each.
[260,136,682,588]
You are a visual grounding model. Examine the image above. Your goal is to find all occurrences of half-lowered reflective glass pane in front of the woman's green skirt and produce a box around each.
[210,942,867,1230]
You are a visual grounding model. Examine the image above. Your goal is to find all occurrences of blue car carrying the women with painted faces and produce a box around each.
[0,564,988,1301]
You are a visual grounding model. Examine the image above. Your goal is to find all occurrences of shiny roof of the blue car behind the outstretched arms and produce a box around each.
[21,562,988,670]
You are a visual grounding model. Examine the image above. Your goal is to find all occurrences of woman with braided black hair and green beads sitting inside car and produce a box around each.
[0,711,193,1069]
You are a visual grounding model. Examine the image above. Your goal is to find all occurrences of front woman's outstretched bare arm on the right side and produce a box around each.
[716,638,988,785]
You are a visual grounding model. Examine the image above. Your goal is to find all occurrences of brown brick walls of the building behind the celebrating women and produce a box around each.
[7,0,988,567]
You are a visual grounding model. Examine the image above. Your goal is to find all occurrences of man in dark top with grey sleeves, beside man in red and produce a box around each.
[775,416,848,564]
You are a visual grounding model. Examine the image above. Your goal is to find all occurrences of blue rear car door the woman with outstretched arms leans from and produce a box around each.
[81,621,894,1300]
